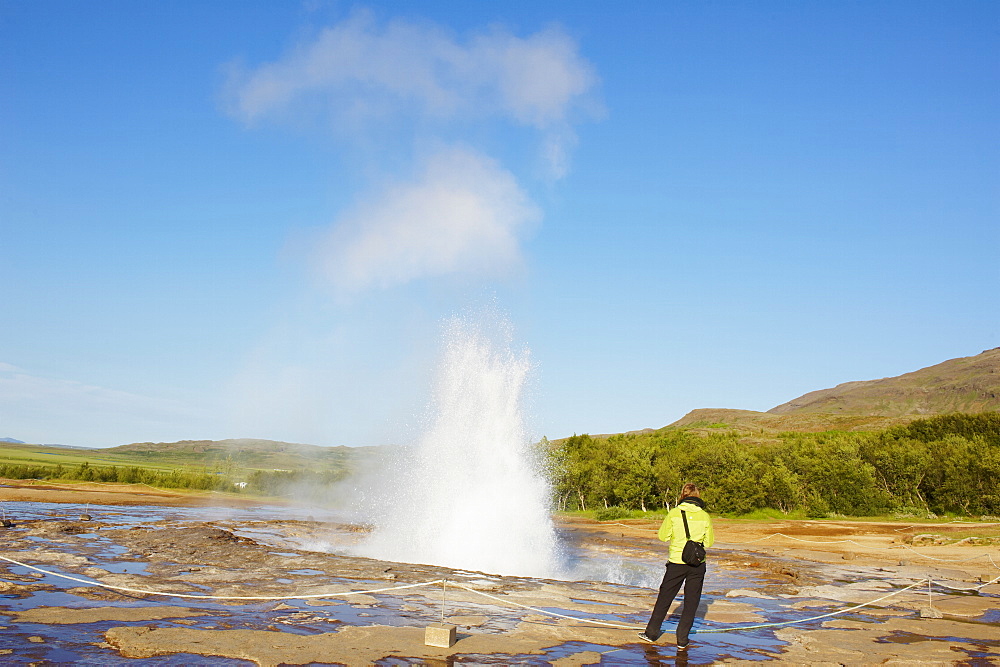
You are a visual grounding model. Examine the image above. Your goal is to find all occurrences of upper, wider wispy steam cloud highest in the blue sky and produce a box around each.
[228,11,597,176]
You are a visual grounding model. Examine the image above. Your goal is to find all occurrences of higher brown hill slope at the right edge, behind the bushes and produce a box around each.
[768,347,1000,417]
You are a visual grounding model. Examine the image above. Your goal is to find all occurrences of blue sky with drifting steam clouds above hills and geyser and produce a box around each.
[0,0,1000,446]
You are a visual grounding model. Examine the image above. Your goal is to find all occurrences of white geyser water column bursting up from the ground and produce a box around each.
[360,318,557,576]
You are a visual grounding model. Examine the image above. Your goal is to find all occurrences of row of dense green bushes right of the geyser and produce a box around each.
[545,412,1000,517]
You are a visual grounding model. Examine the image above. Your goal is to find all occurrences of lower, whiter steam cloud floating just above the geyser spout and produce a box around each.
[318,149,541,293]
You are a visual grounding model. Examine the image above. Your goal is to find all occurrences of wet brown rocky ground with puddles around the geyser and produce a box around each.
[0,502,1000,665]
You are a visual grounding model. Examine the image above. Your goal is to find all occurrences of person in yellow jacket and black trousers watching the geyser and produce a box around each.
[639,483,715,650]
